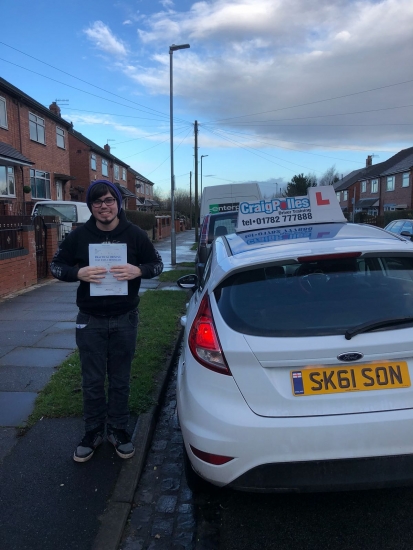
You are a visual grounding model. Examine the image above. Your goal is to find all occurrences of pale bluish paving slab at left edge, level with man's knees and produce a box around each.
[0,347,73,367]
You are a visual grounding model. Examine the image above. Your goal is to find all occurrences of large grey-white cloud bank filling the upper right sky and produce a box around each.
[130,0,413,150]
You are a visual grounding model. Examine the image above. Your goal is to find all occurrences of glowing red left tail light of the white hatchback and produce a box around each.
[188,294,231,376]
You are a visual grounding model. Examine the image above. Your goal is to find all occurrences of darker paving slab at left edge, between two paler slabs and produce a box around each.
[0,367,56,394]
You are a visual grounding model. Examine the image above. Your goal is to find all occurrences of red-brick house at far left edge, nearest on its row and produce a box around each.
[0,78,72,215]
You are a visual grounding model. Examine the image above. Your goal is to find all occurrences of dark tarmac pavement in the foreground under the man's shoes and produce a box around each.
[0,418,130,550]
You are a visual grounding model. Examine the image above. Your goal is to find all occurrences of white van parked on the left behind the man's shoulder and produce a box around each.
[32,200,91,240]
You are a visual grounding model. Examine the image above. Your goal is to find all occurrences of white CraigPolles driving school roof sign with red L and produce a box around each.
[237,186,347,233]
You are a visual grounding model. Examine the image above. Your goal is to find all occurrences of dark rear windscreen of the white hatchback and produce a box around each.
[214,255,413,337]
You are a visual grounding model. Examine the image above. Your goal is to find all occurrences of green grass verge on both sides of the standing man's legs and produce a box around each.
[27,290,188,428]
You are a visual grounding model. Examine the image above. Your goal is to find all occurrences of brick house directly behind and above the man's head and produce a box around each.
[69,127,136,210]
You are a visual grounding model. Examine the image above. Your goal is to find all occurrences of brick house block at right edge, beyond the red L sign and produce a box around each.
[334,147,413,220]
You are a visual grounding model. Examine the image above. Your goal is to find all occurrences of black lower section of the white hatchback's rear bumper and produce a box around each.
[228,455,413,493]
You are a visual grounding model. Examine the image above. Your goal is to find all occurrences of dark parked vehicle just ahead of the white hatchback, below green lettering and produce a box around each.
[195,211,238,277]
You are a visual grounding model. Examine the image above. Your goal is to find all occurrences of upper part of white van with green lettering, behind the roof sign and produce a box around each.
[200,183,263,225]
